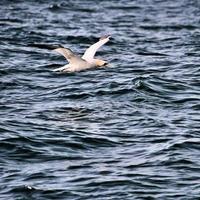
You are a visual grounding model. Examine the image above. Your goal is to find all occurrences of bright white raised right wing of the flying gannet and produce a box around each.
[82,35,110,62]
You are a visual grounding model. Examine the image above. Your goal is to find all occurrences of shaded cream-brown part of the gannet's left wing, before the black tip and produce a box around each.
[54,48,84,64]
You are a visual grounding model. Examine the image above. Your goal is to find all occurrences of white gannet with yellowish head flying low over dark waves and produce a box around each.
[53,35,110,72]
